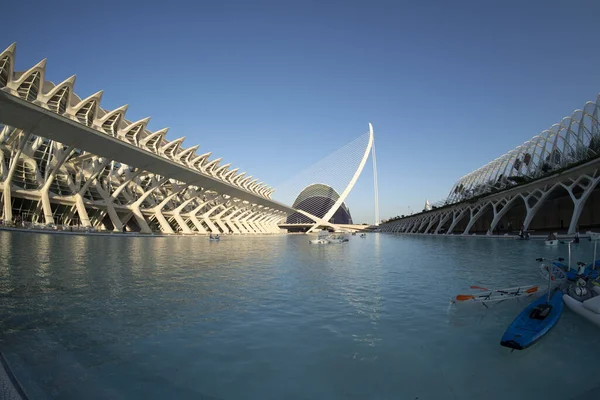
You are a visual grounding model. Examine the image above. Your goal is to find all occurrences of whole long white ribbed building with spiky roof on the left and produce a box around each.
[0,44,293,233]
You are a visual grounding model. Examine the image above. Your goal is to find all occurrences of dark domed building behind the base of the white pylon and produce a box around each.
[287,183,352,224]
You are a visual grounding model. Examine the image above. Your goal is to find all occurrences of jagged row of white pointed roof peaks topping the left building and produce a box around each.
[0,44,274,199]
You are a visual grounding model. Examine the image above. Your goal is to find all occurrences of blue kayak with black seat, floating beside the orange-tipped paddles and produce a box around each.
[500,288,563,350]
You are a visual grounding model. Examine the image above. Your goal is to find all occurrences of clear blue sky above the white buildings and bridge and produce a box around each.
[0,0,600,222]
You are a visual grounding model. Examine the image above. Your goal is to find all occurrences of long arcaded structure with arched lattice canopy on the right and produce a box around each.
[381,95,600,238]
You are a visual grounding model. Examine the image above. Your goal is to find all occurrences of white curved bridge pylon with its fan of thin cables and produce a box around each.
[274,123,377,233]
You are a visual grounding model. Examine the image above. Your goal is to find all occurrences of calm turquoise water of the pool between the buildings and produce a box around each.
[0,232,600,400]
